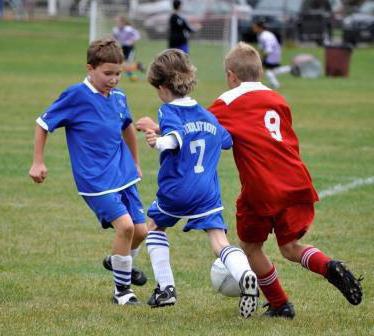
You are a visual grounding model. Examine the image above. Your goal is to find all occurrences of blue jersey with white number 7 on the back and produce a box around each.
[157,97,232,218]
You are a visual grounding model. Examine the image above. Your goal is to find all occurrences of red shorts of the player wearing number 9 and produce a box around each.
[236,203,314,246]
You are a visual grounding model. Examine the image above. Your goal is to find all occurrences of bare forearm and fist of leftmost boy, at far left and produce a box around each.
[29,125,48,183]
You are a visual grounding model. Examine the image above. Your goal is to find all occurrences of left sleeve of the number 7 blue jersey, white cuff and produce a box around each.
[158,105,185,148]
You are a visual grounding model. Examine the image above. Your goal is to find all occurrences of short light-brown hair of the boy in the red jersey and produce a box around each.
[225,42,262,82]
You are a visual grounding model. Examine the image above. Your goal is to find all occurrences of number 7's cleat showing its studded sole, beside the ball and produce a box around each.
[239,270,260,318]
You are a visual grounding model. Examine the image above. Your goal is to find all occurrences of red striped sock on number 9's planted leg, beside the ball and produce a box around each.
[257,265,288,308]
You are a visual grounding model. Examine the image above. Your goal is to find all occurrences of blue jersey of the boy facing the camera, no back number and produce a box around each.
[37,79,140,196]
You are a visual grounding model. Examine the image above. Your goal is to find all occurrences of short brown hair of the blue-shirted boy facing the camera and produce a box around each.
[87,38,124,68]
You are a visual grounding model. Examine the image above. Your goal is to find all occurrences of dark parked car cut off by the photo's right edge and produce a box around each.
[343,1,374,45]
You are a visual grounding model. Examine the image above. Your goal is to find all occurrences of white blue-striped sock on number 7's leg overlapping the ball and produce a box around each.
[219,245,251,282]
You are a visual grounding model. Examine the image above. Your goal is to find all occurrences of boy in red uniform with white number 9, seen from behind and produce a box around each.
[209,42,362,318]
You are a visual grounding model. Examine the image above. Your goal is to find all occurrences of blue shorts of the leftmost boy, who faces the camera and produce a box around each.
[82,184,145,229]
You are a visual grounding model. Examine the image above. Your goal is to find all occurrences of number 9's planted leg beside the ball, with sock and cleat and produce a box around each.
[241,242,295,318]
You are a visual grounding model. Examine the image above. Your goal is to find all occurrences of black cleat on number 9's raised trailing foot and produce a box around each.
[325,260,363,305]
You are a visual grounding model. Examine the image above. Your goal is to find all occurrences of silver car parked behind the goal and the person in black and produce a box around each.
[143,0,252,40]
